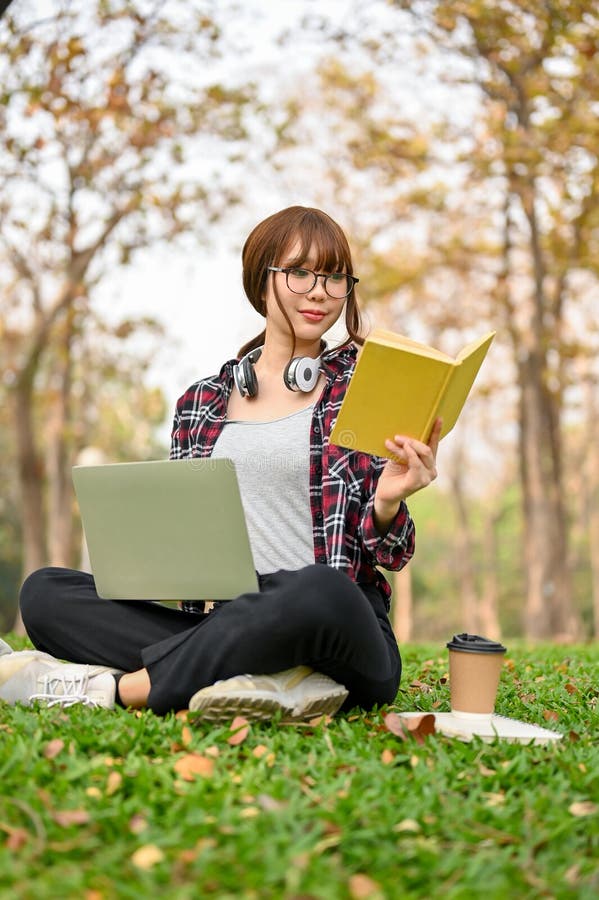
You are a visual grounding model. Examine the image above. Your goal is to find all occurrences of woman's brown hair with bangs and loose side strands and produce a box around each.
[238,206,364,357]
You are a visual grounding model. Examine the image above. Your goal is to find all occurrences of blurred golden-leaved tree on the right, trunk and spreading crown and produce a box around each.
[278,0,599,638]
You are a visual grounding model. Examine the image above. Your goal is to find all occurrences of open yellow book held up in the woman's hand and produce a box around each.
[330,328,495,456]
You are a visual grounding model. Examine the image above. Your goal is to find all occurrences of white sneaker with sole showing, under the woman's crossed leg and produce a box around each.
[189,666,348,722]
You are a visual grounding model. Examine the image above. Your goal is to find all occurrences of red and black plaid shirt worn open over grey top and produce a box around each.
[170,345,414,609]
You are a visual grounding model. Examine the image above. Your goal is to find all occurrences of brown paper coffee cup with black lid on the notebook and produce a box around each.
[447,634,506,719]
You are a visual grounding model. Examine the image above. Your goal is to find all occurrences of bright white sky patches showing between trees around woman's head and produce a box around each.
[10,0,482,441]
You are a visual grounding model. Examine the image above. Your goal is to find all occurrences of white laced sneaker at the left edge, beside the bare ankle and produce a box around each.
[0,650,120,709]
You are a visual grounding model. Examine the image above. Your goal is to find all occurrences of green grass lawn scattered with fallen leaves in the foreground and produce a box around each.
[0,636,599,900]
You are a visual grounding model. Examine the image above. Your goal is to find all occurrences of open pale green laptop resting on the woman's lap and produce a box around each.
[73,458,258,600]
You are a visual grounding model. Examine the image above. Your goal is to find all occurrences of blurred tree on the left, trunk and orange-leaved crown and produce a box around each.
[0,0,252,624]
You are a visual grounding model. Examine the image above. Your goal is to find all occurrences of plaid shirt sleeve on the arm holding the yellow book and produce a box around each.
[359,459,415,572]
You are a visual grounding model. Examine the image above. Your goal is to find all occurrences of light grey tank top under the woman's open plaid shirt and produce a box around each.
[212,406,314,575]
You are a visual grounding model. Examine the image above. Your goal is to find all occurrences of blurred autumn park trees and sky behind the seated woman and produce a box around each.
[0,0,599,641]
